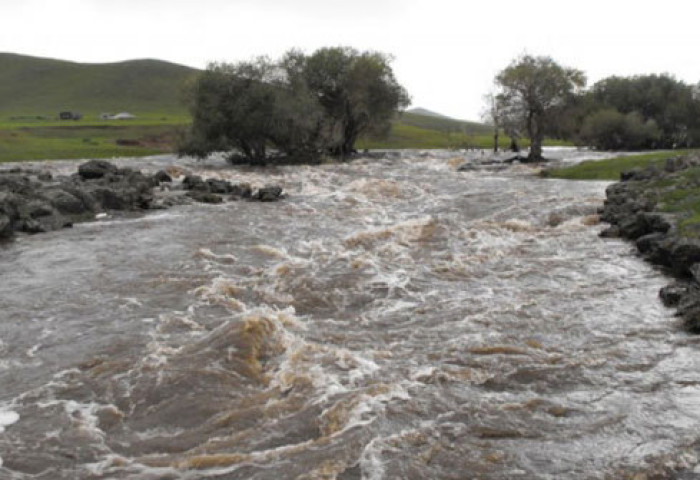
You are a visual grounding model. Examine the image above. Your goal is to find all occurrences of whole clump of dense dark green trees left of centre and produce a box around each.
[179,47,410,164]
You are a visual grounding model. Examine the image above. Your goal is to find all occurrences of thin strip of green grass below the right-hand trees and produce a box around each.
[543,150,695,180]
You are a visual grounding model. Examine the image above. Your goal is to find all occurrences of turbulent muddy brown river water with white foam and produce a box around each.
[0,153,700,480]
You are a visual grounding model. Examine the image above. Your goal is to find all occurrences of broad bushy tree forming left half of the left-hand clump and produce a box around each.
[179,57,323,164]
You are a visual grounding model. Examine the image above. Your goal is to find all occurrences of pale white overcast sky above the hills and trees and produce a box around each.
[0,0,700,120]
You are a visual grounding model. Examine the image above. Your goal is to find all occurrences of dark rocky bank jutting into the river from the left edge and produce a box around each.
[0,160,283,240]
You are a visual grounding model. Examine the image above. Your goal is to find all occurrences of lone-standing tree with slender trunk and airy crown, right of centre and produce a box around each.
[496,55,586,162]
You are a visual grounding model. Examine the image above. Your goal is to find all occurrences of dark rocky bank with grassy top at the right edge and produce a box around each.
[601,156,700,333]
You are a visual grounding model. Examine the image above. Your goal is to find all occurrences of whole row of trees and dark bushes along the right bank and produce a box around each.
[484,55,700,161]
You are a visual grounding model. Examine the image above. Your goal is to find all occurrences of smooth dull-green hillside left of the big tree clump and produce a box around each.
[0,53,198,121]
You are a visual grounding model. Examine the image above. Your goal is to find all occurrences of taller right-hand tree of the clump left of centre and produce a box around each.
[297,47,410,157]
